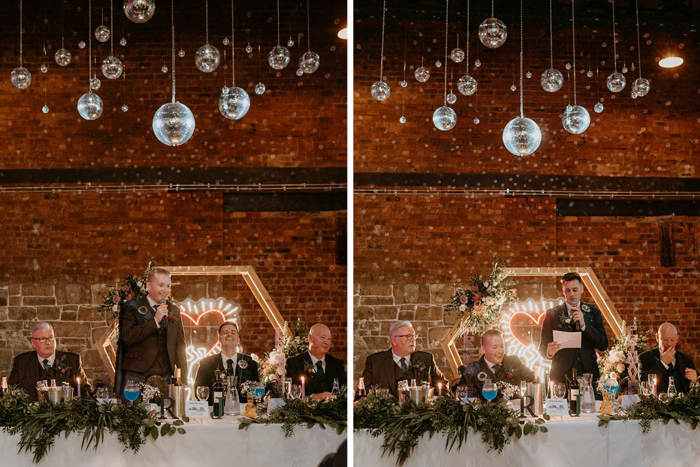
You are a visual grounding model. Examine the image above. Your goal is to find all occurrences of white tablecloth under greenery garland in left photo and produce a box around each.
[0,417,347,467]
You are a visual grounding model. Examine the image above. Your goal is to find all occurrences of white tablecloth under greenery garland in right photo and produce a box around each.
[353,415,700,467]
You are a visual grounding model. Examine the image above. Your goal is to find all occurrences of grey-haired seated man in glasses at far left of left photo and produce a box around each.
[8,322,90,400]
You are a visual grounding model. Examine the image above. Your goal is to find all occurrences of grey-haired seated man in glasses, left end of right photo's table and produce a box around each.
[362,321,446,395]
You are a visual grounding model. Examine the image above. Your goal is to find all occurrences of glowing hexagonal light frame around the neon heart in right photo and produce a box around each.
[440,267,622,378]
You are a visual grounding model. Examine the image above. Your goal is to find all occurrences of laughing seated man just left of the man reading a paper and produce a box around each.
[457,329,535,400]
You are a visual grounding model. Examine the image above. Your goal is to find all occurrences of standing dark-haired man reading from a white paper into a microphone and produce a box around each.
[539,272,608,387]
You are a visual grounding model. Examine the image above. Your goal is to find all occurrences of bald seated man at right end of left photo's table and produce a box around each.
[286,323,347,400]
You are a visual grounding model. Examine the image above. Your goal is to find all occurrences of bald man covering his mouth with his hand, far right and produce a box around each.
[639,323,698,394]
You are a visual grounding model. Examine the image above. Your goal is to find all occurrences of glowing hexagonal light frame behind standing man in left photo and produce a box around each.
[98,266,290,386]
